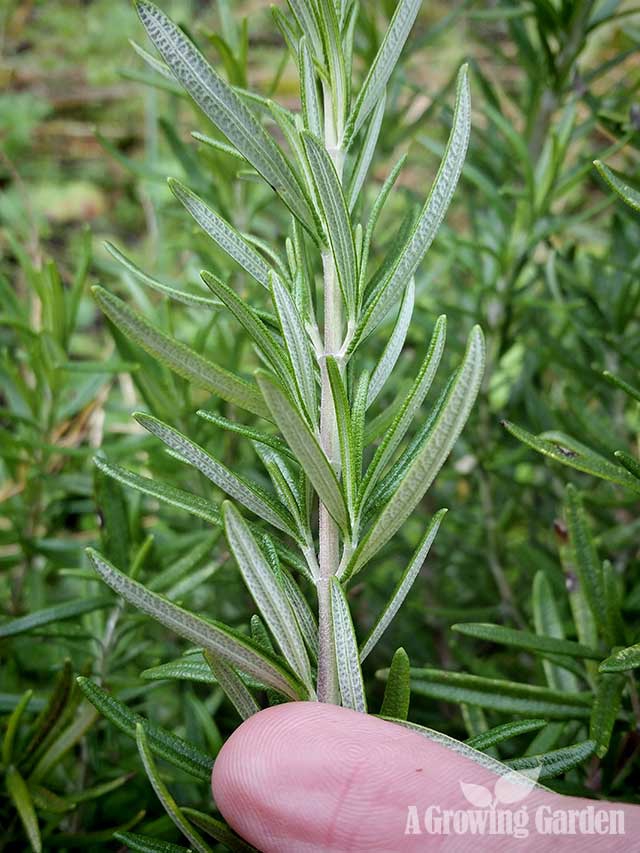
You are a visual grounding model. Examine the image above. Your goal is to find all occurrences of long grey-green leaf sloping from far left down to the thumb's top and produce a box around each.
[87,549,307,699]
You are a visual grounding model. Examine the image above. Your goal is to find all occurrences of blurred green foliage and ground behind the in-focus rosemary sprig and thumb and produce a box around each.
[0,0,640,850]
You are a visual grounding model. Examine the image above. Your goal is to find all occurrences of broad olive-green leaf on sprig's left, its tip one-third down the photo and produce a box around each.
[92,287,268,417]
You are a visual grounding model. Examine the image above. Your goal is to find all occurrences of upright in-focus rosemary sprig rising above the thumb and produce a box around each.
[84,0,484,716]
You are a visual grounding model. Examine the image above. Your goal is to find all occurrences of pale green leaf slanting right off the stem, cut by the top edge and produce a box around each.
[343,0,421,149]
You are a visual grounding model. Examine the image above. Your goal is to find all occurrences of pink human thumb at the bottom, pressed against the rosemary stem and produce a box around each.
[212,702,640,853]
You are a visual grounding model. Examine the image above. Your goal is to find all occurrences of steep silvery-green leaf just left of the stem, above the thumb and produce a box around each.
[222,502,311,689]
